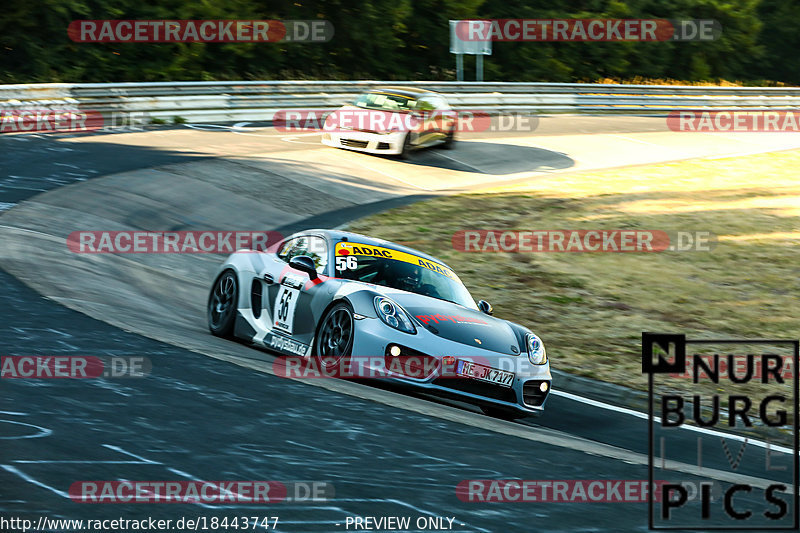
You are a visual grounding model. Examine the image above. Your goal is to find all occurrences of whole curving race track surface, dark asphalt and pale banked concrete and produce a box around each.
[0,116,800,532]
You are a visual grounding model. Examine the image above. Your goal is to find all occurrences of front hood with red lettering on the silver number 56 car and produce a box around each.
[386,291,520,355]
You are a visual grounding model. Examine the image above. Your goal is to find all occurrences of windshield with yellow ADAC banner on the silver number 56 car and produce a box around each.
[336,242,477,309]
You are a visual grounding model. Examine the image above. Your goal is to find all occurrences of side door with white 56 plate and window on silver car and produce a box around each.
[267,235,328,351]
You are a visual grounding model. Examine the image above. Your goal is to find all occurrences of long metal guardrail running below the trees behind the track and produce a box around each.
[0,81,800,122]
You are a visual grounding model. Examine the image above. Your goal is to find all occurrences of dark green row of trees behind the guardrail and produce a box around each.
[0,0,800,84]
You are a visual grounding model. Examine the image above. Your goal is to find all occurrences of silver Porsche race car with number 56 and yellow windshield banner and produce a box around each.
[208,230,552,418]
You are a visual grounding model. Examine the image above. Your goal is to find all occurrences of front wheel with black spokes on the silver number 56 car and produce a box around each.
[314,303,355,374]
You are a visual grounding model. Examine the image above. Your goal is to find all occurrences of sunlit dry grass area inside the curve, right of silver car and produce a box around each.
[349,151,800,416]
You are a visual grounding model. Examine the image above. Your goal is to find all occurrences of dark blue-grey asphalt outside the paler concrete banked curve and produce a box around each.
[0,122,791,532]
